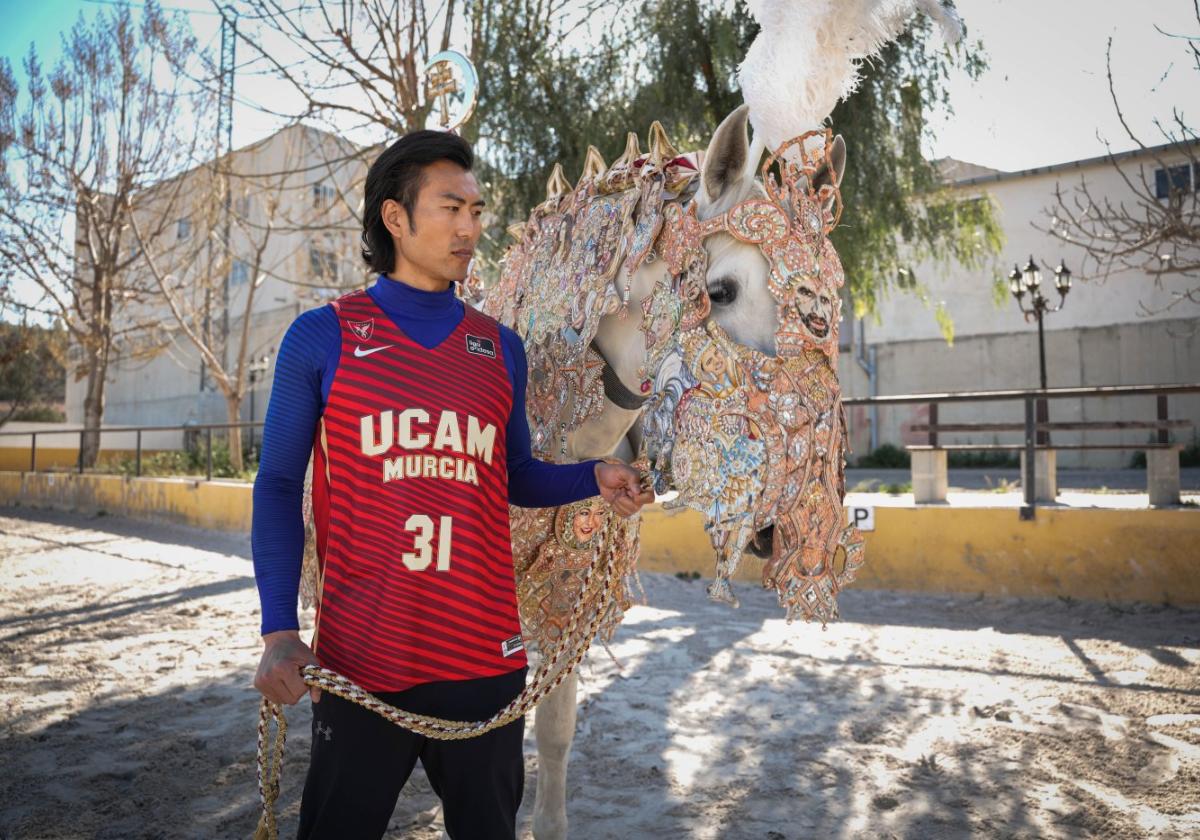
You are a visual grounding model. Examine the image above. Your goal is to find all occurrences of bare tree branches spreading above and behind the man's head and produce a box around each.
[226,0,619,272]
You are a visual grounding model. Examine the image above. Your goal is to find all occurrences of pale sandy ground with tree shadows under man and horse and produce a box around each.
[0,508,1200,840]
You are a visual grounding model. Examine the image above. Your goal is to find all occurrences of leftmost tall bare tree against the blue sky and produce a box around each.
[0,1,206,466]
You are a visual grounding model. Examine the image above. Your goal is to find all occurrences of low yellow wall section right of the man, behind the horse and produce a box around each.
[638,506,1200,606]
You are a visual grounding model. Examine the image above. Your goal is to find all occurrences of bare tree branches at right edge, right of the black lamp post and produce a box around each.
[1038,0,1200,312]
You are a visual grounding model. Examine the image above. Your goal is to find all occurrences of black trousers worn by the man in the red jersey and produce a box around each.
[298,668,526,840]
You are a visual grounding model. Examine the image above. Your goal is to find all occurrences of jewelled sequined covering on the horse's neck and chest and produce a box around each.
[482,140,696,650]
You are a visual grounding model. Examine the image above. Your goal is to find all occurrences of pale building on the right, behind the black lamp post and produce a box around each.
[840,140,1200,467]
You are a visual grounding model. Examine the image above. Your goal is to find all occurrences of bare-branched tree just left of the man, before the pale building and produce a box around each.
[130,126,361,472]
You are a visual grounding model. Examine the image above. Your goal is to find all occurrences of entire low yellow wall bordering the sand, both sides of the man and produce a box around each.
[0,472,1200,606]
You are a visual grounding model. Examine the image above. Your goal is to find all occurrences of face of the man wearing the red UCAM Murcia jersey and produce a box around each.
[383,161,484,283]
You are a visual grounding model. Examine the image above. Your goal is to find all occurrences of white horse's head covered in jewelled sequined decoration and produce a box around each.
[644,108,860,622]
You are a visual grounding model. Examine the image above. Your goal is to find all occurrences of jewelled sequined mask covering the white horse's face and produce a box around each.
[643,126,863,624]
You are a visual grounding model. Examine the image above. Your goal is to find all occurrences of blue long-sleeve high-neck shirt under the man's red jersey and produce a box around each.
[251,275,600,635]
